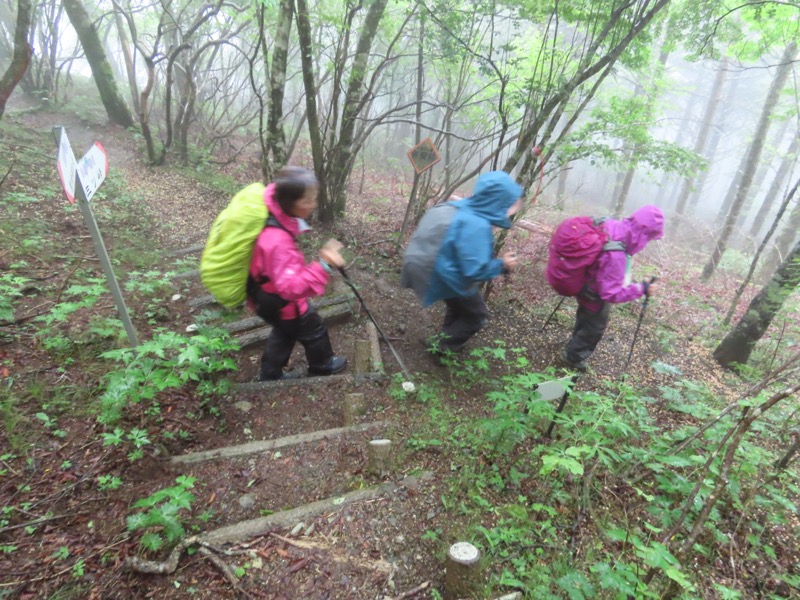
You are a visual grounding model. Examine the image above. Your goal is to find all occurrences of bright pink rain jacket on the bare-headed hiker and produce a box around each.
[250,183,330,320]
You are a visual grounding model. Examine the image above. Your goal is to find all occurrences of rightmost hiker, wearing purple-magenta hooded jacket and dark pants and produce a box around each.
[556,205,664,371]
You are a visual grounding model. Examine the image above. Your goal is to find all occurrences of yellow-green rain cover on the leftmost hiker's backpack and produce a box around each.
[200,183,269,307]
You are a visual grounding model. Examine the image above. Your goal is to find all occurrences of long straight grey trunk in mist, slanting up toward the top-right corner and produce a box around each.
[700,42,797,281]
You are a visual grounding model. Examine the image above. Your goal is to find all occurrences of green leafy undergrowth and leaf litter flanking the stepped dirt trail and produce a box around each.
[0,104,800,599]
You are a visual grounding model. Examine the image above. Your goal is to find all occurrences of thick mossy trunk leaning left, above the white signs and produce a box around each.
[64,0,133,127]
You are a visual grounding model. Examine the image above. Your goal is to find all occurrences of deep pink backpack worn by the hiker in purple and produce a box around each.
[545,217,626,296]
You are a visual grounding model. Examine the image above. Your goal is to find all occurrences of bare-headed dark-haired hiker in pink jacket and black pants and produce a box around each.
[248,167,347,381]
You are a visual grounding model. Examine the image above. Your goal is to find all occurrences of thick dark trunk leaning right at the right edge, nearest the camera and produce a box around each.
[714,237,800,368]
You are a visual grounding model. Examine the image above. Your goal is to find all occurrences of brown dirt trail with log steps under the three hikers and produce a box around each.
[1,105,752,600]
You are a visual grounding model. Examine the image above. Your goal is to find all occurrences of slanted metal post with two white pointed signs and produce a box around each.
[53,126,139,346]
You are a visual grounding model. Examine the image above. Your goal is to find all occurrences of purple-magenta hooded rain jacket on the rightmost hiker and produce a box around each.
[578,205,664,312]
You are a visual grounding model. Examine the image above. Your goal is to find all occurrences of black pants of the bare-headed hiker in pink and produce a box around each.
[259,304,333,381]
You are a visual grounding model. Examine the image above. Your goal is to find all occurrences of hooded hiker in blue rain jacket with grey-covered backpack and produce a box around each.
[402,171,522,354]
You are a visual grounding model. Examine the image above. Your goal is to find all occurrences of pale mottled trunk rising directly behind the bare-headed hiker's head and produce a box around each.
[264,0,294,171]
